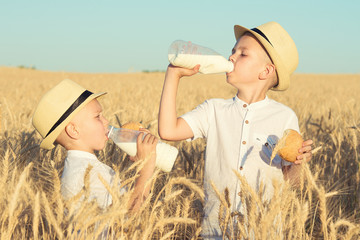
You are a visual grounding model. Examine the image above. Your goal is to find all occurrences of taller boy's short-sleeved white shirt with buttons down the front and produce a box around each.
[181,96,299,239]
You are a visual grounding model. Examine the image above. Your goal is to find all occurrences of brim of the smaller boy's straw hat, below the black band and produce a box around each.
[40,92,106,150]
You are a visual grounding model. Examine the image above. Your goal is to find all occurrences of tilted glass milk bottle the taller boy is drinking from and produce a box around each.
[168,40,234,74]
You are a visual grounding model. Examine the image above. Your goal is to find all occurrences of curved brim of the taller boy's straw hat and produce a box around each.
[234,25,290,91]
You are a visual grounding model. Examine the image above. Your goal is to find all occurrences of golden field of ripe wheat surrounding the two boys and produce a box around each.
[0,67,360,239]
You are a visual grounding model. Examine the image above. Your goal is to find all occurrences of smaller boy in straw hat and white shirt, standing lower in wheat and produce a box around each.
[33,80,158,210]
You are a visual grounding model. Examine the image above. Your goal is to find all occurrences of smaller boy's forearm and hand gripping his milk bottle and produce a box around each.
[129,133,158,212]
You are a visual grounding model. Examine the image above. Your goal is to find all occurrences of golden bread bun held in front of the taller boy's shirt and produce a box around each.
[278,129,304,162]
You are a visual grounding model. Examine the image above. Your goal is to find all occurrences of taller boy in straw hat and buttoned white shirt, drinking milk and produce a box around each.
[159,22,312,239]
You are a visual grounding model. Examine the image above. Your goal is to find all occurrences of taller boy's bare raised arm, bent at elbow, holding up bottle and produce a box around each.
[159,64,200,141]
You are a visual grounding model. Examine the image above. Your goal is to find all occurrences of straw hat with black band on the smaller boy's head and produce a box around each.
[32,79,106,149]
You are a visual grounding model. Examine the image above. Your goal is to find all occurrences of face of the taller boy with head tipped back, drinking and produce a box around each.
[226,33,270,87]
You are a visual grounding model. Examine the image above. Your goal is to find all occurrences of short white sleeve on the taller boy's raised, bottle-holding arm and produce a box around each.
[181,100,211,140]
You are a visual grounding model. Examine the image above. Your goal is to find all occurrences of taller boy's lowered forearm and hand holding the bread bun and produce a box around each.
[282,140,313,186]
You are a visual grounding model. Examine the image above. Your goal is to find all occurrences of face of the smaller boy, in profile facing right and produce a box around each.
[71,99,109,153]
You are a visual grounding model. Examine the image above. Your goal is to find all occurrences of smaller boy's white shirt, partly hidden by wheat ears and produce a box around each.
[61,150,115,208]
